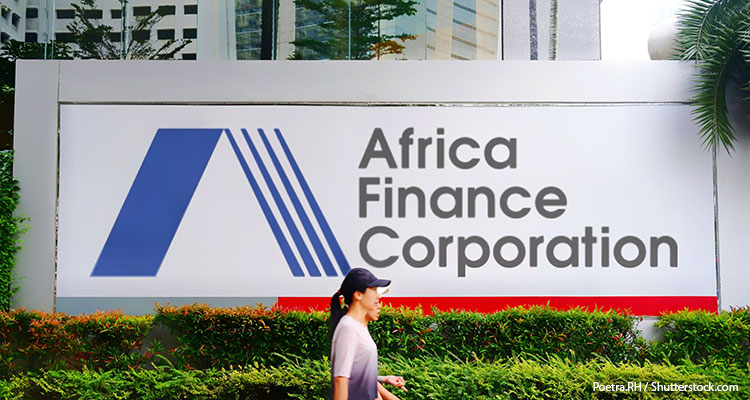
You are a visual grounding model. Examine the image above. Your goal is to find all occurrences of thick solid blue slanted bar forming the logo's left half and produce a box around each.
[91,129,222,276]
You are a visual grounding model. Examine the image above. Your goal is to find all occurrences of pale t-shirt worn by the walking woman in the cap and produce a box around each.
[330,315,378,400]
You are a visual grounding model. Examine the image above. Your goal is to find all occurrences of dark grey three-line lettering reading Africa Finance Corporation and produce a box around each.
[358,128,678,277]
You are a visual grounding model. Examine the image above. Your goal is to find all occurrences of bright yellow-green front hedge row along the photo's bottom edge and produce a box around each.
[0,358,750,400]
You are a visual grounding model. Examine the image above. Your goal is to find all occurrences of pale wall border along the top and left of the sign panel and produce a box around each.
[14,60,736,311]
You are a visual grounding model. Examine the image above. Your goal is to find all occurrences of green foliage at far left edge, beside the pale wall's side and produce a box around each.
[0,150,26,311]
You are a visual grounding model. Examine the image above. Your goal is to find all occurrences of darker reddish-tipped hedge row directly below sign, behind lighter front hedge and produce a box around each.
[0,305,750,376]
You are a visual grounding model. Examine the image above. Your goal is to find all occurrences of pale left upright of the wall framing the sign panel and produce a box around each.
[13,61,60,311]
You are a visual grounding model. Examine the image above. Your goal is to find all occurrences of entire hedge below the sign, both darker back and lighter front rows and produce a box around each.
[0,304,750,400]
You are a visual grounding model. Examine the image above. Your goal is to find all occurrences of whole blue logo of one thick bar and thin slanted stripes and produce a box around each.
[91,129,350,277]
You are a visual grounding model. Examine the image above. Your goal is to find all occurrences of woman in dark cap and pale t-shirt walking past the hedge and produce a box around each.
[329,268,406,400]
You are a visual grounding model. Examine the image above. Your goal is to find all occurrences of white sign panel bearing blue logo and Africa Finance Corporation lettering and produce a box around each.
[57,105,716,310]
